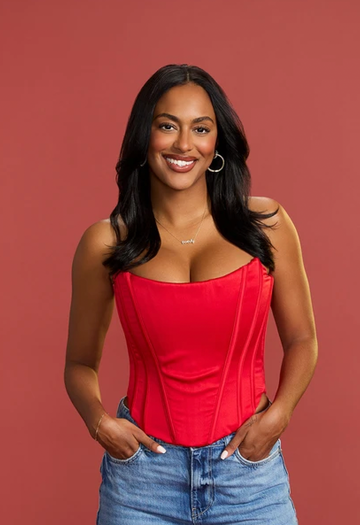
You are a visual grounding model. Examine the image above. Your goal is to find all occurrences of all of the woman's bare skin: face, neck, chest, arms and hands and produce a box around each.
[64,84,317,461]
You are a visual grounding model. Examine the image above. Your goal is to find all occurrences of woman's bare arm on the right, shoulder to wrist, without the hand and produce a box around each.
[271,201,318,425]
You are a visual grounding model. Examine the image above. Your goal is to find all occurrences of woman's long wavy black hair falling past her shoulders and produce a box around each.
[103,64,278,279]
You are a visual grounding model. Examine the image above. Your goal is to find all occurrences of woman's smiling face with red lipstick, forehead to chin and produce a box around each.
[147,83,217,189]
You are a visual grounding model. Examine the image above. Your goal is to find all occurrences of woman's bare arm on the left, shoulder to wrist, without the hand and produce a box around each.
[64,221,114,437]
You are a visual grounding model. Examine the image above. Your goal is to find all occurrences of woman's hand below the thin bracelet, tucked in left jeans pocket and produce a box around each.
[97,414,166,459]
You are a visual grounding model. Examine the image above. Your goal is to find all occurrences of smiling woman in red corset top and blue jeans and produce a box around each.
[65,64,317,525]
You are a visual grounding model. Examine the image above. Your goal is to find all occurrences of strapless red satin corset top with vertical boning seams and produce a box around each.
[114,257,274,446]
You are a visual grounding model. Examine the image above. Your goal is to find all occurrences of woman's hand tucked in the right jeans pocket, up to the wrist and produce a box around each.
[220,404,289,461]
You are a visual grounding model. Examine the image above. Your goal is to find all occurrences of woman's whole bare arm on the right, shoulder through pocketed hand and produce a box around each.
[225,199,318,461]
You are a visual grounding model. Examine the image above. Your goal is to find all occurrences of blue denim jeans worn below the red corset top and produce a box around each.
[96,396,298,525]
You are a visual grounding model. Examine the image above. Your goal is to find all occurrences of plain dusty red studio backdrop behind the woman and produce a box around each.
[0,0,360,525]
